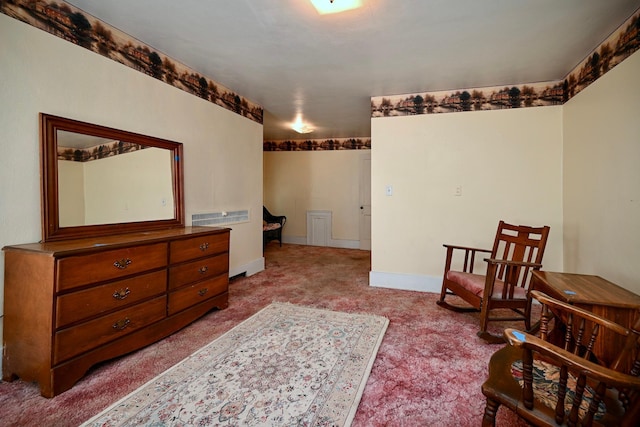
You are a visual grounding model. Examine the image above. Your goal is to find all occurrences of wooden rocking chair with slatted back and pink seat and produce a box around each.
[437,221,549,343]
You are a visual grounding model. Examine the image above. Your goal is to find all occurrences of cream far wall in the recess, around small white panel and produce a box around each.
[264,150,371,248]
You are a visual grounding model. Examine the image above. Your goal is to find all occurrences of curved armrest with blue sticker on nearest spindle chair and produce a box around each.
[504,328,640,390]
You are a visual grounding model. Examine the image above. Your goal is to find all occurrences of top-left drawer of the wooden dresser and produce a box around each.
[57,243,167,292]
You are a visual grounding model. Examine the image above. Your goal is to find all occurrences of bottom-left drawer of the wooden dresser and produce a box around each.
[53,295,167,364]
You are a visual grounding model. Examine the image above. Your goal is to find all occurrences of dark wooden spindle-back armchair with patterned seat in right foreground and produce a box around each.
[482,291,640,426]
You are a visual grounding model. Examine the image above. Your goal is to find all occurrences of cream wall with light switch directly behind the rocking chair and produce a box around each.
[370,106,562,291]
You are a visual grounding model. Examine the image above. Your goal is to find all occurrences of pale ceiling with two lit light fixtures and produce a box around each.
[67,0,640,140]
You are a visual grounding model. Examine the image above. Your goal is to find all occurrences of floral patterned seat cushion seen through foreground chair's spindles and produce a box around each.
[511,360,606,420]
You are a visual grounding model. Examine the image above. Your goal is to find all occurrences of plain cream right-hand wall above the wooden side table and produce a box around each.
[563,52,640,294]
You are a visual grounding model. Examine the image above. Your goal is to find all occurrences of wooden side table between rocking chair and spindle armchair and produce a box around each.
[530,271,640,366]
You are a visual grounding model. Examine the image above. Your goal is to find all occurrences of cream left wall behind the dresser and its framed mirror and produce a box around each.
[0,15,264,344]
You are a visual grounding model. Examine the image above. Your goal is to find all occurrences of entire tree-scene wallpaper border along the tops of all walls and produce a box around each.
[0,0,640,151]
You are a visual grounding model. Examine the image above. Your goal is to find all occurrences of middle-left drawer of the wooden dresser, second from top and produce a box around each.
[56,270,167,329]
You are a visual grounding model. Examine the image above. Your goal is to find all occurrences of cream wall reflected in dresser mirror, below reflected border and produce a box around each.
[58,147,175,227]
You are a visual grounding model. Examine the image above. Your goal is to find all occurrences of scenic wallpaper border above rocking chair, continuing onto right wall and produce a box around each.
[371,9,640,118]
